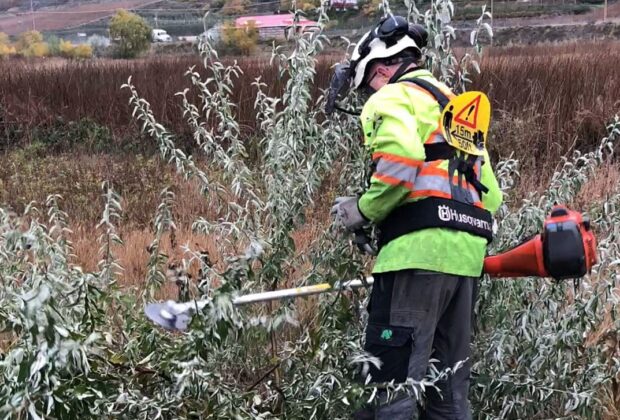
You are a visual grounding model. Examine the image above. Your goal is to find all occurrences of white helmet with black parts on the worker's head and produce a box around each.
[349,15,428,89]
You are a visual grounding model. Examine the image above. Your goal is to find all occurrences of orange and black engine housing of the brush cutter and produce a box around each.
[484,206,596,280]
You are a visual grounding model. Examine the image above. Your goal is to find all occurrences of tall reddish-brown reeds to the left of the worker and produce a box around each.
[0,55,331,142]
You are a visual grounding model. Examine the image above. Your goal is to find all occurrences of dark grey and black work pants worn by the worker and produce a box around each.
[354,270,476,420]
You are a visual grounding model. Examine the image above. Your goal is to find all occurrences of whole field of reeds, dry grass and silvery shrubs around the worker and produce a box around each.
[0,16,620,419]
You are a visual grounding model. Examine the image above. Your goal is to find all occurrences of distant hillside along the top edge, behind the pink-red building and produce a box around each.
[0,0,620,37]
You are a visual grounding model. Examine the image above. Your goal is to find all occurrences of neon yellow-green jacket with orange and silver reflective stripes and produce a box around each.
[358,70,502,277]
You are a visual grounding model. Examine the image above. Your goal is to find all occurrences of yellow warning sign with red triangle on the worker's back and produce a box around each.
[441,91,491,156]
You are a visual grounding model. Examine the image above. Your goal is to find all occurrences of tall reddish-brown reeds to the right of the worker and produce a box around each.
[474,42,620,174]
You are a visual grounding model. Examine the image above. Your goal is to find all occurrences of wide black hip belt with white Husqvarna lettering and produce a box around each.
[378,197,493,247]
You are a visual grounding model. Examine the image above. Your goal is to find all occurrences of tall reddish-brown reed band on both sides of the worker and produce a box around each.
[0,41,620,168]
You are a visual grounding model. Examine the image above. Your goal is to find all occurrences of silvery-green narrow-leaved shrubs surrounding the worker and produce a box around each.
[0,0,620,419]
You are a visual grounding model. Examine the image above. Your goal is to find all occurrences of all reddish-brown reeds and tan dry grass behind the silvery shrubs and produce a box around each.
[0,43,620,286]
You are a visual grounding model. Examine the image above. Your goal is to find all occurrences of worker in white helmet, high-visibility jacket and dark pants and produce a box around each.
[328,16,502,420]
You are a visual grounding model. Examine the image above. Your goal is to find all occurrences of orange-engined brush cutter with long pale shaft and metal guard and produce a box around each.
[145,206,596,330]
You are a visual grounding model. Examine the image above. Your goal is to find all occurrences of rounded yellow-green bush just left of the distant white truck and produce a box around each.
[110,10,151,58]
